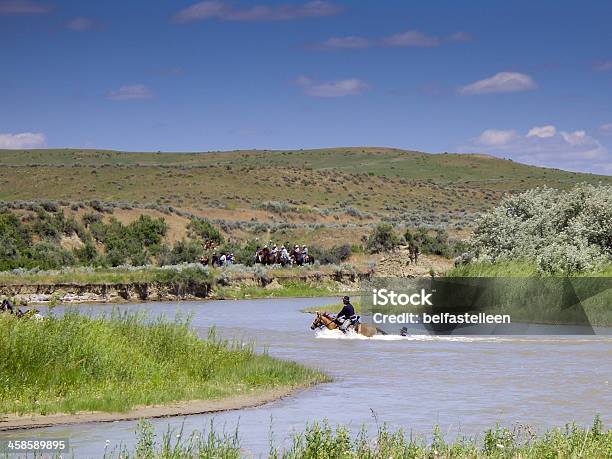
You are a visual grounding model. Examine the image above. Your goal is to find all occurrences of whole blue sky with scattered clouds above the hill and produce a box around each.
[0,0,612,174]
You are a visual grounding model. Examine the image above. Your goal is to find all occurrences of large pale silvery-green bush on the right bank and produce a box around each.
[471,184,612,274]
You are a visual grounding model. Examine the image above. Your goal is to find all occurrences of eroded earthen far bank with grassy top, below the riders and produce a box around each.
[0,264,371,305]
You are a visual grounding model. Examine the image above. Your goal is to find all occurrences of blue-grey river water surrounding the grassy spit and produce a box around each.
[0,298,612,457]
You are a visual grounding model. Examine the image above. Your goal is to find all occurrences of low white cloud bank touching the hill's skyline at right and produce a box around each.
[459,125,612,173]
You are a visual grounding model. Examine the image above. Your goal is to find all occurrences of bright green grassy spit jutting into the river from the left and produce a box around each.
[0,312,327,414]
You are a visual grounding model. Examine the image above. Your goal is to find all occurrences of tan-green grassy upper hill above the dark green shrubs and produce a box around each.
[0,148,612,248]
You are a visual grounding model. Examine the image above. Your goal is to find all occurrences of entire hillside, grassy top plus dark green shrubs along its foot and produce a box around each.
[0,148,612,276]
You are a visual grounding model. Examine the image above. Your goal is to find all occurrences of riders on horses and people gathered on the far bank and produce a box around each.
[200,243,314,266]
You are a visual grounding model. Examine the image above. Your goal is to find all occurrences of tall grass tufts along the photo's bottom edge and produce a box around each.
[105,417,612,459]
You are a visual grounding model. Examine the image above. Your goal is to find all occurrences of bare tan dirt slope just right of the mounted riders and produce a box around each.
[375,246,453,277]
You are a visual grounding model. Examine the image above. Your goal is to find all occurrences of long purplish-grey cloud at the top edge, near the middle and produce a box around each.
[173,0,342,23]
